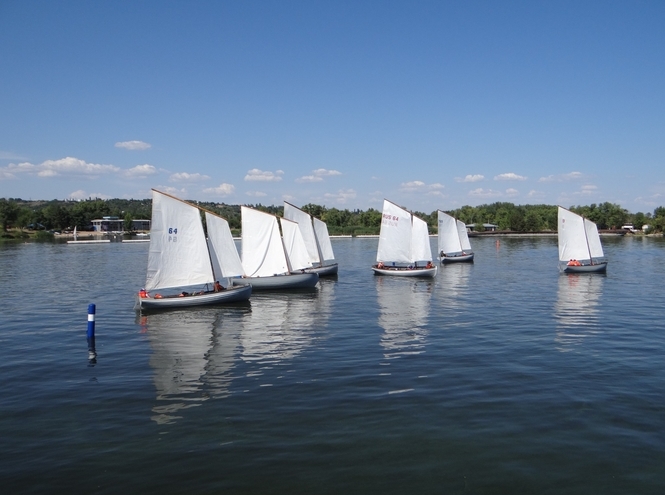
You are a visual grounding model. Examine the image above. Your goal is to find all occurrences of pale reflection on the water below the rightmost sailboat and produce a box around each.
[554,273,605,350]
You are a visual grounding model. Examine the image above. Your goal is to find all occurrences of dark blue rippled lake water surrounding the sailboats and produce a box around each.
[0,237,665,494]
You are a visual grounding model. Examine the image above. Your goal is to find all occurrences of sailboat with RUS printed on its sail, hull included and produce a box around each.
[372,199,437,277]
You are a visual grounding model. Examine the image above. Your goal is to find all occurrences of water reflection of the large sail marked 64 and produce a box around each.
[139,310,217,424]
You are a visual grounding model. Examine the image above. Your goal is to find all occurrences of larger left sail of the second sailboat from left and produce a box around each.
[241,206,289,277]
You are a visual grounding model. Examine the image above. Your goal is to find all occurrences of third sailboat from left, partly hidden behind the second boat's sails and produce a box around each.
[284,201,338,277]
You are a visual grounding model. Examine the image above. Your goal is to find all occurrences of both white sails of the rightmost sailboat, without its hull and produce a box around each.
[558,206,603,262]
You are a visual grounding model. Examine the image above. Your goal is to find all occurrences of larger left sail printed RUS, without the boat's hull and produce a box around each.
[376,200,412,263]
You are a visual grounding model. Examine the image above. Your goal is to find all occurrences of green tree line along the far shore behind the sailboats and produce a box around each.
[0,198,665,235]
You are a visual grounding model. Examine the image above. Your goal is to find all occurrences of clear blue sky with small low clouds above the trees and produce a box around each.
[0,0,665,213]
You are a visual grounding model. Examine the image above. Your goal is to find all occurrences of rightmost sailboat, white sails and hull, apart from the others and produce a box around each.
[558,206,607,273]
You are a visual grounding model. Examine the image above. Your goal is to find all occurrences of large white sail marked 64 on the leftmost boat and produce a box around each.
[145,190,214,290]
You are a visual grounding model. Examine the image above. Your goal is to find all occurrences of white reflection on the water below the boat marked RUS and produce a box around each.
[376,277,435,359]
